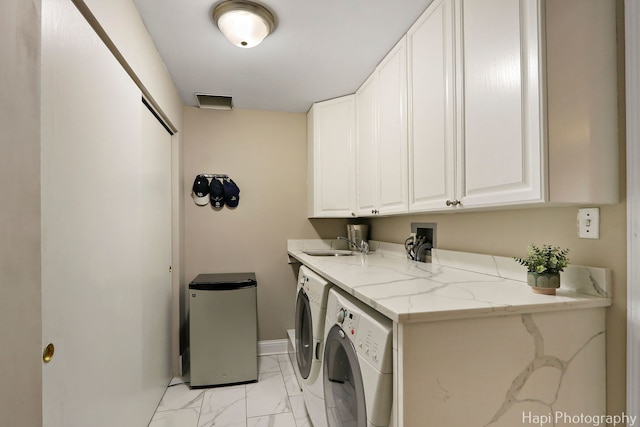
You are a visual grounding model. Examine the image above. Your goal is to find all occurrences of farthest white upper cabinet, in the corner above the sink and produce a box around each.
[307,95,355,218]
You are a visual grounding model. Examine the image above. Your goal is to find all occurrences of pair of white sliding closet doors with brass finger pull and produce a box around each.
[41,0,171,427]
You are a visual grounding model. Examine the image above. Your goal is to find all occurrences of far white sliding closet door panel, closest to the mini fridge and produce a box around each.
[140,104,172,407]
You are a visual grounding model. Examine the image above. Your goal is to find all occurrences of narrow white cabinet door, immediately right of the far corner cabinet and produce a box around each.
[356,72,380,216]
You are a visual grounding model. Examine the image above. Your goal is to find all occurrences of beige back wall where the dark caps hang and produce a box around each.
[182,107,346,341]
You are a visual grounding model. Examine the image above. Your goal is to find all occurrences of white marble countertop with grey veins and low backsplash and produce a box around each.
[287,240,611,323]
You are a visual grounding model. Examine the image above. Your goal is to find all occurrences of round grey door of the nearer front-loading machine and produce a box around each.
[323,325,367,427]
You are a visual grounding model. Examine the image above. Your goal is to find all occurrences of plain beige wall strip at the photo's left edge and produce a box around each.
[0,0,42,427]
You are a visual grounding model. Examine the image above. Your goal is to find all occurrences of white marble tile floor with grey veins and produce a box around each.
[149,354,312,427]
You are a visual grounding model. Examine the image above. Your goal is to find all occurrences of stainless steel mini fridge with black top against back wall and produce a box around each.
[189,273,258,387]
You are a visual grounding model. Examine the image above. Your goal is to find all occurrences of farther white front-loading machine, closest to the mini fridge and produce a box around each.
[295,266,332,427]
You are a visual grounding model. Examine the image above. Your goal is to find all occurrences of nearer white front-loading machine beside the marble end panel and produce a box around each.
[323,288,393,427]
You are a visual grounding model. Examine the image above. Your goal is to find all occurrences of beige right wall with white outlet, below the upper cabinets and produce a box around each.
[370,209,627,414]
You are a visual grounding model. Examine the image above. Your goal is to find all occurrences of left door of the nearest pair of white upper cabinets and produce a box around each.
[407,0,456,212]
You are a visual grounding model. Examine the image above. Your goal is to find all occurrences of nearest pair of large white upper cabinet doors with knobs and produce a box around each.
[407,0,544,212]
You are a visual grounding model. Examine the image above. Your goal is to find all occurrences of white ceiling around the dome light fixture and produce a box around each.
[133,0,432,112]
